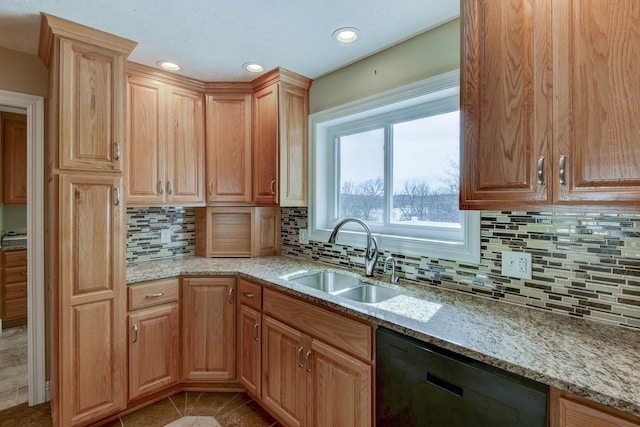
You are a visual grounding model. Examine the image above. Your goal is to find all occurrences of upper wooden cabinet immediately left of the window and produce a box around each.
[253,68,311,206]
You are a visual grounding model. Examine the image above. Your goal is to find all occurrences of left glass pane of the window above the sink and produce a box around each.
[338,129,384,221]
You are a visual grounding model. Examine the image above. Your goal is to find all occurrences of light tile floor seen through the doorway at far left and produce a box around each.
[0,325,29,410]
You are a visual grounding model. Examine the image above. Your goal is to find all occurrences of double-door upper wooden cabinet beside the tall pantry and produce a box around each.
[127,63,204,206]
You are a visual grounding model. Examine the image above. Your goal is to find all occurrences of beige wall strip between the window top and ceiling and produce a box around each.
[309,19,460,113]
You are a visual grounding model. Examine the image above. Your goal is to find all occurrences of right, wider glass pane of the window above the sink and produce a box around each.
[391,111,461,225]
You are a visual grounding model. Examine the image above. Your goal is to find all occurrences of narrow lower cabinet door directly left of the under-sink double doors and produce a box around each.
[238,304,262,398]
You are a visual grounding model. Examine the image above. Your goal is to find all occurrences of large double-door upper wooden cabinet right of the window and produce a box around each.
[460,0,640,211]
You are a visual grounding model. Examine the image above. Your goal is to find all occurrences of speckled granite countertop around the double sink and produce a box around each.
[127,257,640,416]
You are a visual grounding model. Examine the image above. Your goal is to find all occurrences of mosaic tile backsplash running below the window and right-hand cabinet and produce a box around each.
[282,208,640,328]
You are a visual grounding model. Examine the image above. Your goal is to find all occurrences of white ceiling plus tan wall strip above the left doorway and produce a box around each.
[0,0,460,81]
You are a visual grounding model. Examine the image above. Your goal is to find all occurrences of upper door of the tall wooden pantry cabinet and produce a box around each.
[57,39,126,172]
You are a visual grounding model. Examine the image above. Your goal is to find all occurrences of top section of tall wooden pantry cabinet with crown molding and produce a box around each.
[40,14,136,172]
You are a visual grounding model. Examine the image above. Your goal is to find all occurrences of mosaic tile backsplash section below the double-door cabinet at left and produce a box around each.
[127,207,196,264]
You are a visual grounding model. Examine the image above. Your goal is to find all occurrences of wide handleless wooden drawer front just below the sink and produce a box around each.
[262,289,373,361]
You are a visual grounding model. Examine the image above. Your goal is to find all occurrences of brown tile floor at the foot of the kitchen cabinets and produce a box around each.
[0,392,280,427]
